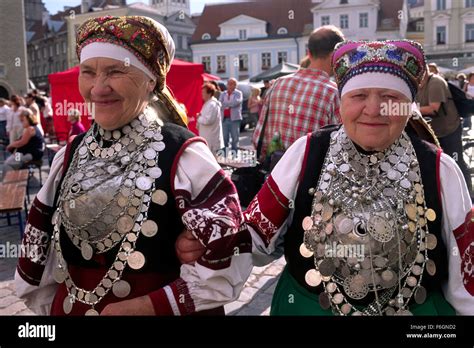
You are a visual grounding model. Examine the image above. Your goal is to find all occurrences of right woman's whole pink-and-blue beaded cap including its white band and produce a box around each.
[332,40,426,100]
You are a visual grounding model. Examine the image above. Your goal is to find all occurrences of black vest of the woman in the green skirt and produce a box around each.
[284,126,448,304]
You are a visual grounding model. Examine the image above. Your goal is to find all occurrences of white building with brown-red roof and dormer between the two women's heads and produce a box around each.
[191,0,313,80]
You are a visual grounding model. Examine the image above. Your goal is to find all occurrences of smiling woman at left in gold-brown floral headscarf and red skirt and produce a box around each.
[16,17,251,315]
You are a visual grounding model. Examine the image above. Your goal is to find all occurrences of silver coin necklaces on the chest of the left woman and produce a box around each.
[53,112,167,315]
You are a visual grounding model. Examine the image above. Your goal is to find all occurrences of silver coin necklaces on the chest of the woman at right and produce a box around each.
[300,127,437,315]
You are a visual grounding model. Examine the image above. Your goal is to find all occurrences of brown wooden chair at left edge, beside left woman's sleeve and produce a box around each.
[0,183,26,238]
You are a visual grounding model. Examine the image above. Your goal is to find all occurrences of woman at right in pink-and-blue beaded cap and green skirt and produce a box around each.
[178,41,474,315]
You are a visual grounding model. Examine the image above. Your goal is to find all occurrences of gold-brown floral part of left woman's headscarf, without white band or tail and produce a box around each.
[76,16,173,78]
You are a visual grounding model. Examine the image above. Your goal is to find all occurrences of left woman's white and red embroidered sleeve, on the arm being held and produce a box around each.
[152,142,252,315]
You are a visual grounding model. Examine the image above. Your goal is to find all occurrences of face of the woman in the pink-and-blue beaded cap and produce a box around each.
[341,88,411,151]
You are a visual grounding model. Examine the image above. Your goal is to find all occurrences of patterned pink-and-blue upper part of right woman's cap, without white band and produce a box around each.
[332,40,426,98]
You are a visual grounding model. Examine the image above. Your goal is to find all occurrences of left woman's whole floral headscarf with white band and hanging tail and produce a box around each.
[76,16,187,127]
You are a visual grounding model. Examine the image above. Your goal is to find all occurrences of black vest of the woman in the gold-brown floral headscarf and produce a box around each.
[54,123,195,274]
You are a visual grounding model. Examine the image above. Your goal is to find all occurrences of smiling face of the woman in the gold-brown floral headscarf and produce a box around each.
[79,58,155,130]
